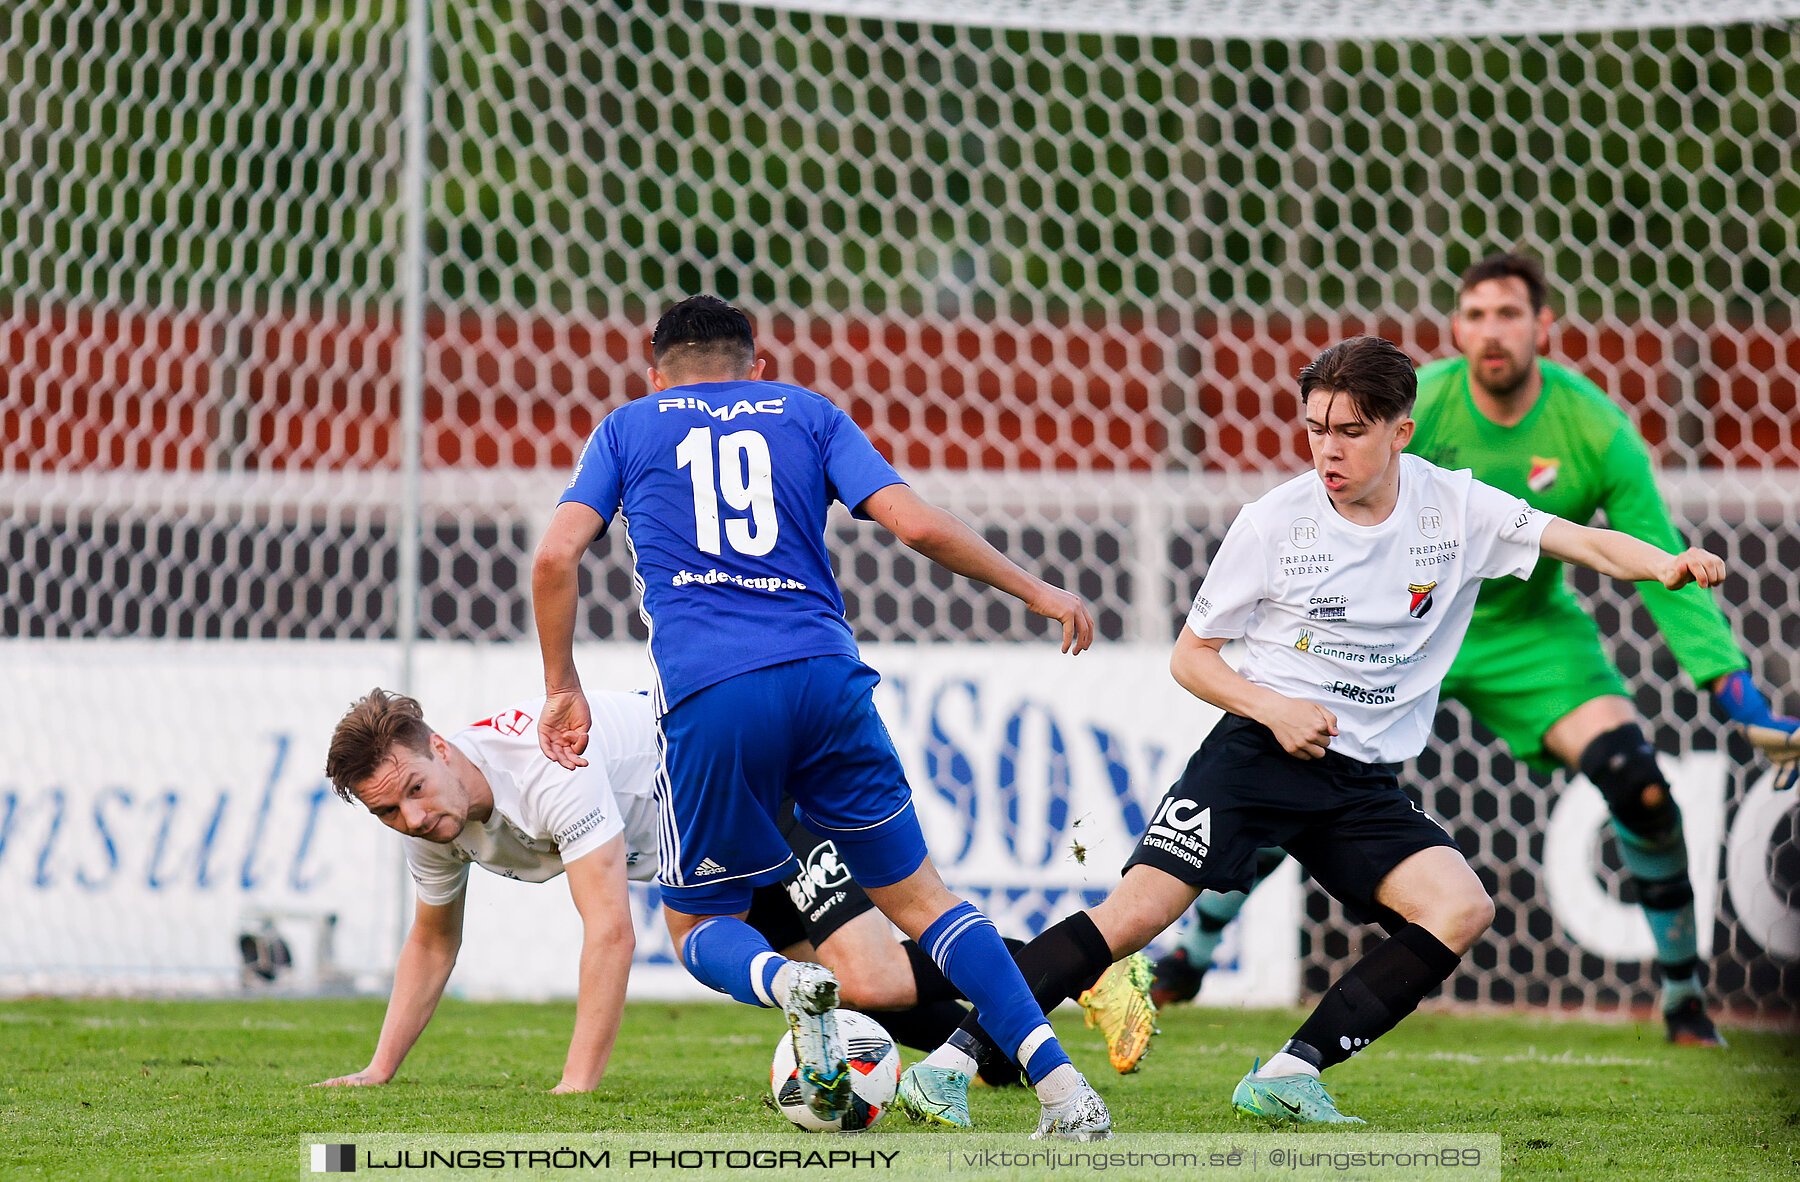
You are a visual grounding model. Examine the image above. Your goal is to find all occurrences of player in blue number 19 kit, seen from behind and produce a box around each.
[531,295,1111,1141]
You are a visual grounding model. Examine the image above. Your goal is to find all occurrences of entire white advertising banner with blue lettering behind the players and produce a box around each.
[0,640,1300,1004]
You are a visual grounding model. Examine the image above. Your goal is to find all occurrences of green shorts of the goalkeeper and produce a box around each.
[1444,604,1629,770]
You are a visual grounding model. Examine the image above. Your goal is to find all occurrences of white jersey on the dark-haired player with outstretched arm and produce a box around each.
[1188,455,1553,763]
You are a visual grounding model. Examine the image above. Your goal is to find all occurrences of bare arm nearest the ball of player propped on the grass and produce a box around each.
[551,837,637,1094]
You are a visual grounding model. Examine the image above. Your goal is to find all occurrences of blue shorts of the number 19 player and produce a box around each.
[657,657,925,916]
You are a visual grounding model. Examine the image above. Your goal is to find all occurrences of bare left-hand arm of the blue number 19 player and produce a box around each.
[531,502,607,770]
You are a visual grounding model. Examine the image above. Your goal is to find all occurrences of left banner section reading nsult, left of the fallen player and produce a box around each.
[0,640,400,993]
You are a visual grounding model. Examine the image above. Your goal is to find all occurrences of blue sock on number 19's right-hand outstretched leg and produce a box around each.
[918,903,1069,1083]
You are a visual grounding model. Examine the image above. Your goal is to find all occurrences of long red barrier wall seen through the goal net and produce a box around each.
[0,309,1800,471]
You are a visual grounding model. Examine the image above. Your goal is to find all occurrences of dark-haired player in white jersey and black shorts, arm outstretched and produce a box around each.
[900,336,1724,1123]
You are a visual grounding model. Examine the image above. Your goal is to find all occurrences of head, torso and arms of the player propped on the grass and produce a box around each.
[320,689,657,1094]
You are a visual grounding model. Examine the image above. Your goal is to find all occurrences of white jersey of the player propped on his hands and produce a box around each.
[405,693,659,903]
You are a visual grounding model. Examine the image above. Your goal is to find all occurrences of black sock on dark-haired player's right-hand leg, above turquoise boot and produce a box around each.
[1283,923,1462,1070]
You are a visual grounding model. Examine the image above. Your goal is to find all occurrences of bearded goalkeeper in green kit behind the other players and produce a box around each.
[1152,254,1800,1045]
